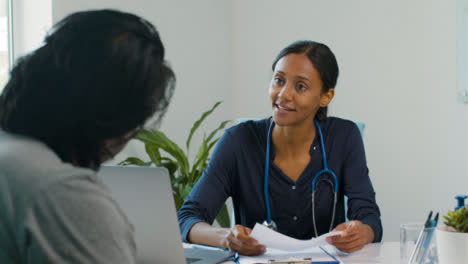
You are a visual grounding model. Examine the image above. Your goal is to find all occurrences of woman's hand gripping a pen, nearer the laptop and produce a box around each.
[224,225,266,256]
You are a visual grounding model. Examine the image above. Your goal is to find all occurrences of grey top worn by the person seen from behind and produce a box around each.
[0,131,136,264]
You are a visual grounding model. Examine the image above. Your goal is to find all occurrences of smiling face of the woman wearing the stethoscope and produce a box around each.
[269,53,334,126]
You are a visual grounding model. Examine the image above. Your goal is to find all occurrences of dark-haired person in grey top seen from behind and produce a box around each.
[0,10,175,264]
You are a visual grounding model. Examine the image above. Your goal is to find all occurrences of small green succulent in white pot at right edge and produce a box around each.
[436,207,468,264]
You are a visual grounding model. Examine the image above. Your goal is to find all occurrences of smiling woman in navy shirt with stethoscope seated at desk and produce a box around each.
[178,41,382,255]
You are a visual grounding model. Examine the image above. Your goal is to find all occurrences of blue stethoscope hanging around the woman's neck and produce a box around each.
[263,120,338,236]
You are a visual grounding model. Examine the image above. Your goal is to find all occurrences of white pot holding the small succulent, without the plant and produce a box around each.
[436,228,468,264]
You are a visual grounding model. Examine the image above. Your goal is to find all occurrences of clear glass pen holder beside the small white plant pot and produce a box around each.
[400,223,439,264]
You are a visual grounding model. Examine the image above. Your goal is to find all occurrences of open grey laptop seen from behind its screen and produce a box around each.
[98,166,232,264]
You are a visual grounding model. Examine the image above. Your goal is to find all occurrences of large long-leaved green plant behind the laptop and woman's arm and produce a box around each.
[119,102,230,227]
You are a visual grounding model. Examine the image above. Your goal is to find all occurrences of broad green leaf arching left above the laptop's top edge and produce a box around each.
[135,129,189,177]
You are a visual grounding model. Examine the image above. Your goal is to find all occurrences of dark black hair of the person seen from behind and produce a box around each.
[0,10,175,169]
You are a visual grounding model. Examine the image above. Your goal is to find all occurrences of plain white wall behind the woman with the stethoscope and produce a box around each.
[53,0,468,241]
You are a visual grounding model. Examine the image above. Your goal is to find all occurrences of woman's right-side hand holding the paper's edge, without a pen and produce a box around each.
[326,220,374,253]
